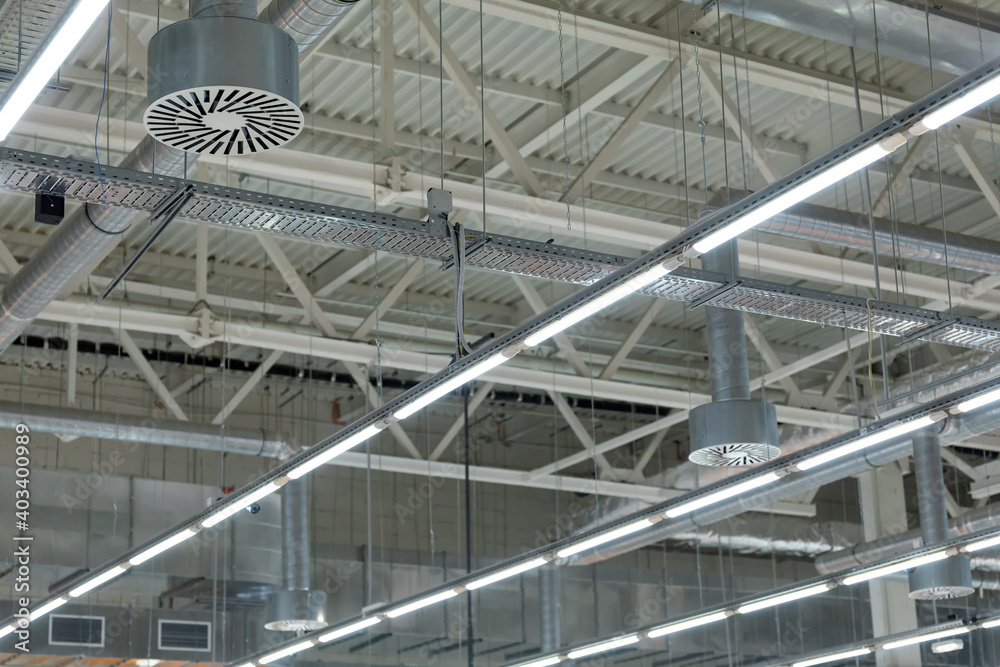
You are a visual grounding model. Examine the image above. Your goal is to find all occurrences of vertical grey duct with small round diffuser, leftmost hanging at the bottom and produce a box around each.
[264,477,327,632]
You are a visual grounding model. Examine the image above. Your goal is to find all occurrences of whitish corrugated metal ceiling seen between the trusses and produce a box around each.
[4,0,1000,408]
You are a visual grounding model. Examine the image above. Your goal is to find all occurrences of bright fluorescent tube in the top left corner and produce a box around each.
[0,0,108,141]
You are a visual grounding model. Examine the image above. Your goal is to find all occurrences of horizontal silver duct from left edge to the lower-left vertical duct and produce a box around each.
[0,401,291,458]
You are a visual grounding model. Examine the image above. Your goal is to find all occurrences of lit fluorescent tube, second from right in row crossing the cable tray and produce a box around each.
[693,134,906,253]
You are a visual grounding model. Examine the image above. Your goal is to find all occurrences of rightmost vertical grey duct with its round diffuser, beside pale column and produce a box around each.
[910,429,975,600]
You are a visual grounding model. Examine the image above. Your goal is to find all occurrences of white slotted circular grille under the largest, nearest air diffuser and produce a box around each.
[143,86,303,155]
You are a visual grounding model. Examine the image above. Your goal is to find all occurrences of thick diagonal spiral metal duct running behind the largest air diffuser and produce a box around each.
[0,0,357,352]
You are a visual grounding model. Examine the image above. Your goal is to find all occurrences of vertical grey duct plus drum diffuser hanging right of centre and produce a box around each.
[689,241,781,467]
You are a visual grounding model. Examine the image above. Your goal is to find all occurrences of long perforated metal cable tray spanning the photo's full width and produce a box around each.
[0,148,1000,352]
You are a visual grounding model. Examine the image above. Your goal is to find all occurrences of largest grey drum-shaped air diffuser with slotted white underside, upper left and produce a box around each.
[143,16,303,155]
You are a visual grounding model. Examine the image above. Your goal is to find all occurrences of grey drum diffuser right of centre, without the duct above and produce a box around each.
[688,400,781,467]
